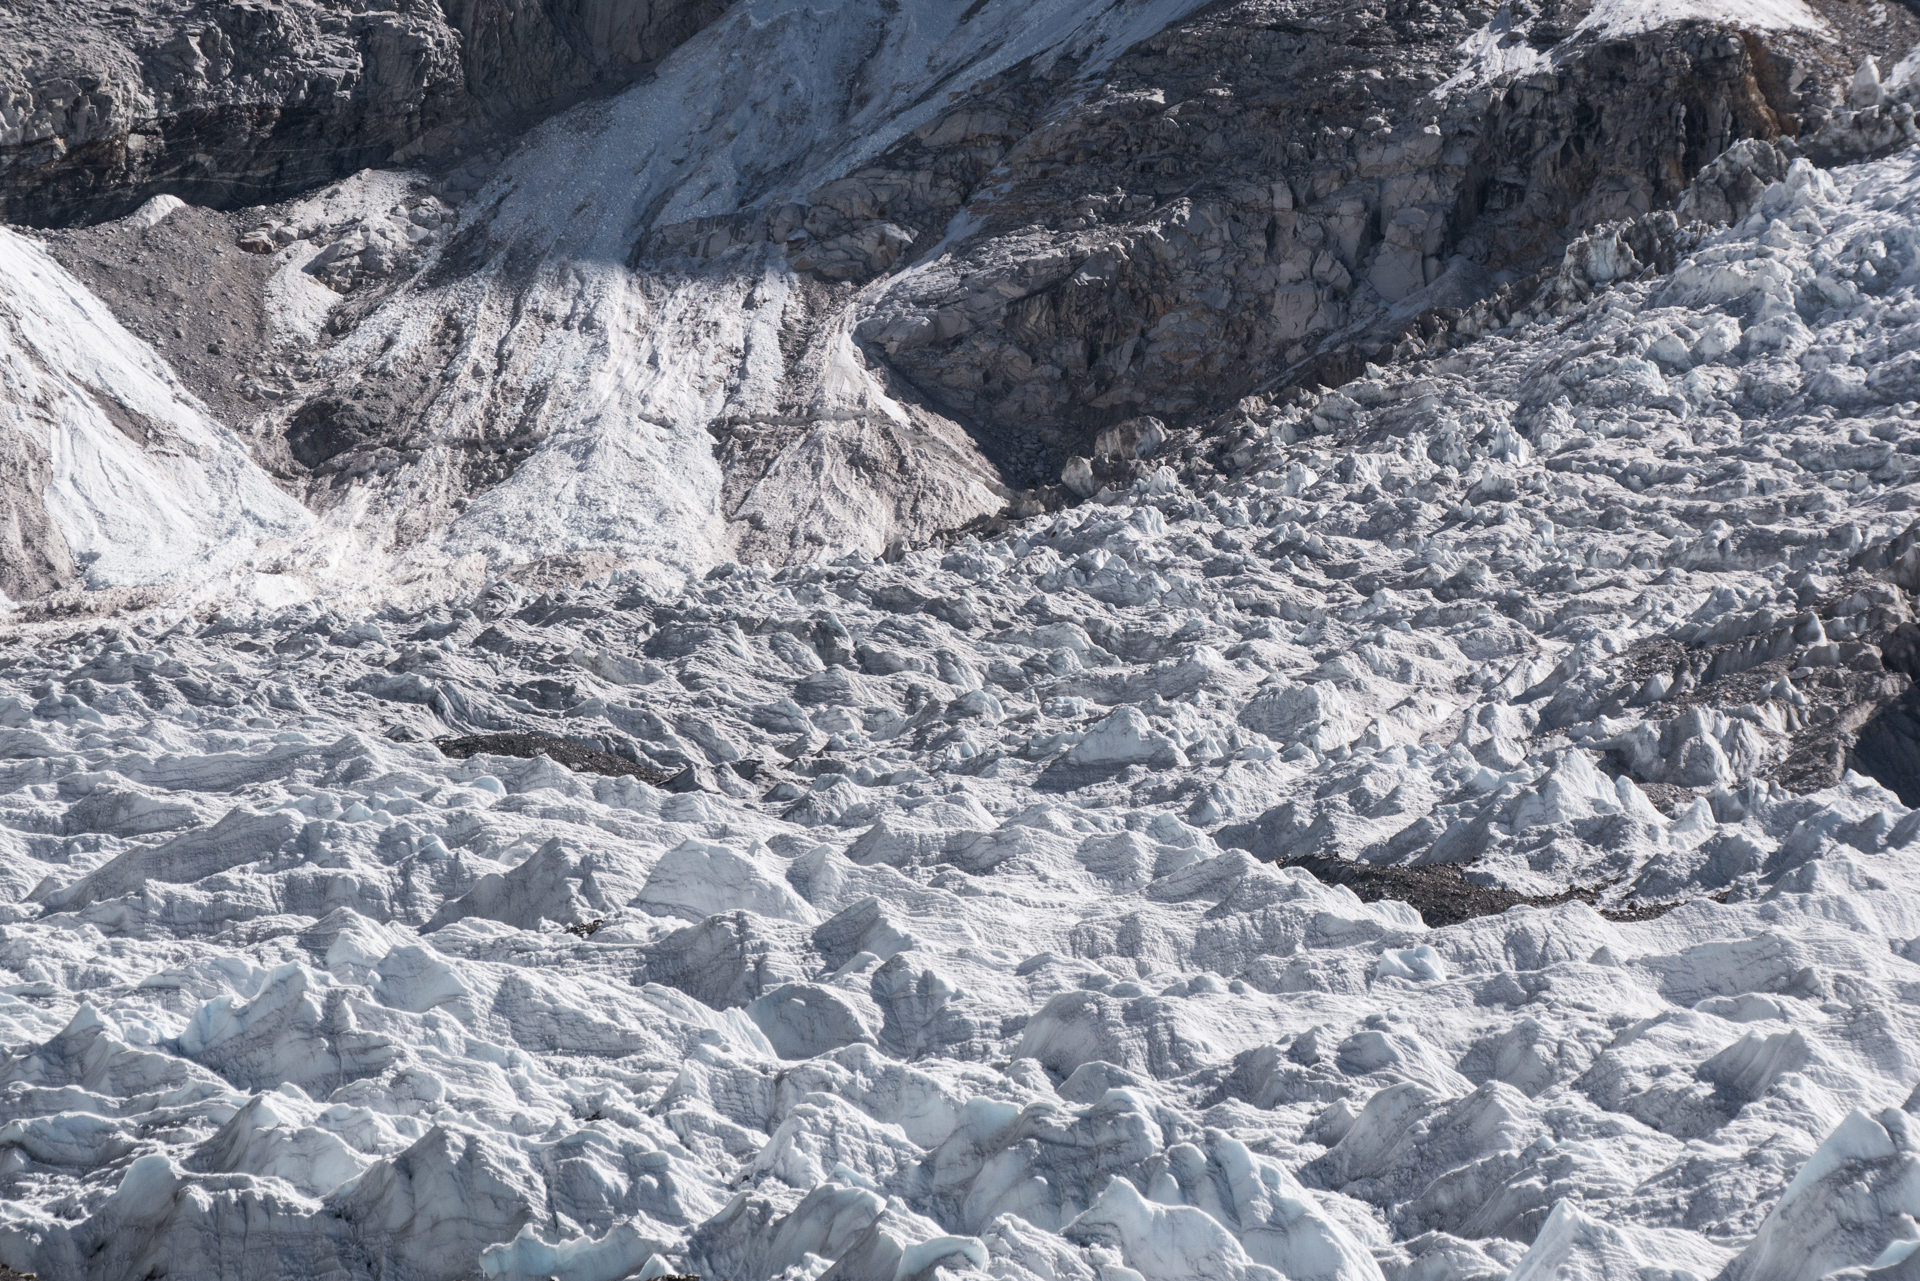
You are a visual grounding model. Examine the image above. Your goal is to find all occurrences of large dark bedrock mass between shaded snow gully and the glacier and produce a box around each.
[634,0,1910,486]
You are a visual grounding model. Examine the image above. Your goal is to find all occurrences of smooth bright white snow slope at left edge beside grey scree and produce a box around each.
[0,229,313,599]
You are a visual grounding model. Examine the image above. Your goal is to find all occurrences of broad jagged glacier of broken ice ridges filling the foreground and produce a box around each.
[15,148,1920,1281]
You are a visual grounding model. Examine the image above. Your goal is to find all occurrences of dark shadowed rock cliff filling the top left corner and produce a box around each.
[0,0,722,227]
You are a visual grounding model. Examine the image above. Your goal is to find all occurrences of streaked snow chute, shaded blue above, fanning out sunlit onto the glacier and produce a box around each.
[220,0,1213,603]
